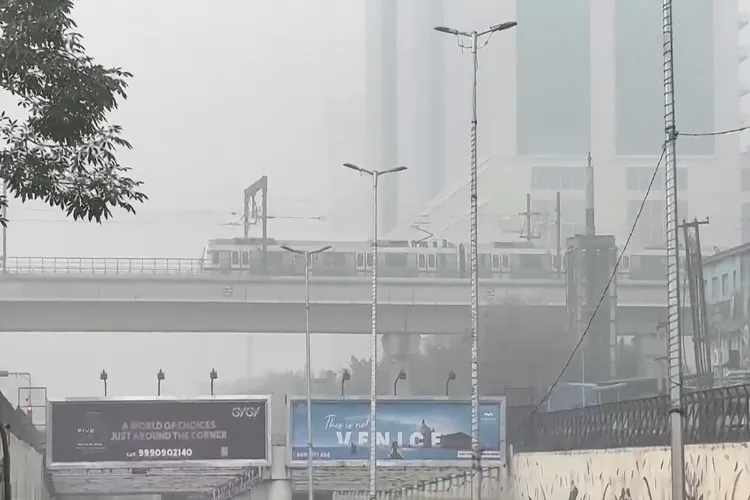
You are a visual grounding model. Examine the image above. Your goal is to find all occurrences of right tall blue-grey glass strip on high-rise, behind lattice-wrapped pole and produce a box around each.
[614,0,715,155]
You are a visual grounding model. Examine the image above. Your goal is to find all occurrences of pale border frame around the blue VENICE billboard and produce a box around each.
[286,395,508,470]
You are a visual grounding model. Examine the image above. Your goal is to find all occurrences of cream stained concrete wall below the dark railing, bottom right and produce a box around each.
[510,443,750,500]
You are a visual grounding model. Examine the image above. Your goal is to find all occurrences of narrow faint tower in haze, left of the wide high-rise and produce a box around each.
[366,0,446,234]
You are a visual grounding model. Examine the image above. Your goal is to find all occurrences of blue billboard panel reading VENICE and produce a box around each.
[289,398,505,466]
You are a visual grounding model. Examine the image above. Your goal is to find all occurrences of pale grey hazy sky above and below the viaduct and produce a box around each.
[0,0,750,400]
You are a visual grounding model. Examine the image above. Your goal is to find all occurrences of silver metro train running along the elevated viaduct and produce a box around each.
[202,238,666,280]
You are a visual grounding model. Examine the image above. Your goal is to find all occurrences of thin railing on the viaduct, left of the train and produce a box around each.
[6,257,203,275]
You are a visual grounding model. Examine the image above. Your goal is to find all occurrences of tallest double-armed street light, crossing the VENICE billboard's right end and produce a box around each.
[435,21,518,500]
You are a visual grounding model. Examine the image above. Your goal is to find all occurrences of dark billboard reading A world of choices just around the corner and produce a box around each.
[47,396,270,468]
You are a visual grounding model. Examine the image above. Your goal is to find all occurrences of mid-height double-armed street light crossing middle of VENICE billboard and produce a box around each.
[344,163,406,500]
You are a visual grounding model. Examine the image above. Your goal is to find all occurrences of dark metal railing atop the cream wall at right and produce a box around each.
[508,385,750,451]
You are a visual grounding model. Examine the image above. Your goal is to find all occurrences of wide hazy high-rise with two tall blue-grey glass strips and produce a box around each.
[396,0,750,247]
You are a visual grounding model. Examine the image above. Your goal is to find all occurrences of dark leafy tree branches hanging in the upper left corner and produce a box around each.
[0,0,147,224]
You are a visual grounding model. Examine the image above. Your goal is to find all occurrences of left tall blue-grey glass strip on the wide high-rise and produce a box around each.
[513,0,592,156]
